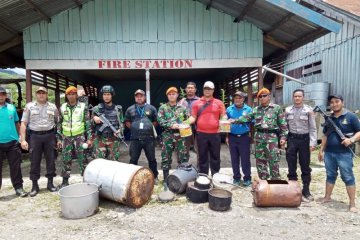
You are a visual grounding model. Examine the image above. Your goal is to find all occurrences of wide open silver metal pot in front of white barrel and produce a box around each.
[58,183,99,219]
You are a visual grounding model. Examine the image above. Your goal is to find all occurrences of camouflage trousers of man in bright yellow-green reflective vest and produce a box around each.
[61,135,88,178]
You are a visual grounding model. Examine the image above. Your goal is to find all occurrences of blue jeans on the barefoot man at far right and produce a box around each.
[324,152,355,186]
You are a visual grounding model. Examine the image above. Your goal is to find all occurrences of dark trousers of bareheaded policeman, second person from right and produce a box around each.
[286,133,311,185]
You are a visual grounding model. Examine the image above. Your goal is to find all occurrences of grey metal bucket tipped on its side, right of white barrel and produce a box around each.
[166,164,198,193]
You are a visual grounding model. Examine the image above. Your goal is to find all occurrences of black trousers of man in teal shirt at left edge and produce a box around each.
[0,141,24,189]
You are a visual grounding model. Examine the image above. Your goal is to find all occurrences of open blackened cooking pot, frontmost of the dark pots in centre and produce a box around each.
[209,188,232,211]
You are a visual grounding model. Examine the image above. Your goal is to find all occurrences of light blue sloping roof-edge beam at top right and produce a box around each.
[265,0,341,33]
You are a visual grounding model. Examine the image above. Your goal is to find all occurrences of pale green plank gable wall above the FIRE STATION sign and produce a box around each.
[23,0,263,60]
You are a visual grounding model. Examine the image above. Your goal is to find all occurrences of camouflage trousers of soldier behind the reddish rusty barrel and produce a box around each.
[255,141,280,180]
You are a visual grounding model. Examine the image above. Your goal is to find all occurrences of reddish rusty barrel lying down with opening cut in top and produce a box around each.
[252,180,301,207]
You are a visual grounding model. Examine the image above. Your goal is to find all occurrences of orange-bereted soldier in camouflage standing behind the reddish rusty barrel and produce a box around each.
[232,88,288,180]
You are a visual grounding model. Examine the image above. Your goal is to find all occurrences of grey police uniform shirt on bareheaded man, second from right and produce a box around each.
[285,105,317,146]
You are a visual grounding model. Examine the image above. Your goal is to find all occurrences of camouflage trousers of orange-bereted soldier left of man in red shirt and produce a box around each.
[161,131,189,170]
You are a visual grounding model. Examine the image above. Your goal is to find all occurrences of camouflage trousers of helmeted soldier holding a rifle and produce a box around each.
[94,136,120,161]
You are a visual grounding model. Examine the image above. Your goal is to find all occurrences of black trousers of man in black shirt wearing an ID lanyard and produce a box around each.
[129,138,159,178]
